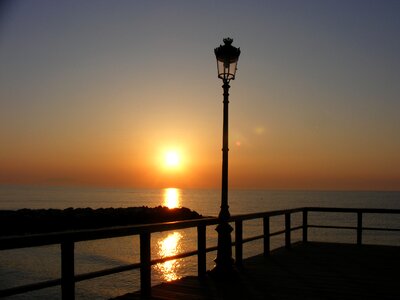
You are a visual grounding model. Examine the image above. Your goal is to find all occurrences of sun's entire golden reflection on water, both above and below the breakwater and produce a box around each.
[155,188,183,281]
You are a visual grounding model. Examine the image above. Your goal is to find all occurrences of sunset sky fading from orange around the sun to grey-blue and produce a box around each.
[0,0,400,190]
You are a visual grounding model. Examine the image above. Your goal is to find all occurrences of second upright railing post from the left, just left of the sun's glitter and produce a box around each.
[140,232,151,298]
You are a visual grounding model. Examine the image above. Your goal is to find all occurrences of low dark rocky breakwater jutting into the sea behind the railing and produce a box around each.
[0,206,202,236]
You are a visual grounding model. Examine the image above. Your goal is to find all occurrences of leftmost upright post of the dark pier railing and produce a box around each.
[61,241,75,300]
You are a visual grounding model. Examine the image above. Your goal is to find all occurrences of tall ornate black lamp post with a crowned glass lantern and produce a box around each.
[214,38,240,275]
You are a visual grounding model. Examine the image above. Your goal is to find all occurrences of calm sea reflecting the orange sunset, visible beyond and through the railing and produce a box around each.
[0,186,400,299]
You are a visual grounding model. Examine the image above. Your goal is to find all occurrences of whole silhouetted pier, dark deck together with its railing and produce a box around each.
[0,207,400,300]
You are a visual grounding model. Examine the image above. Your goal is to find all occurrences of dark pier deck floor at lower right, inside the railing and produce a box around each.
[115,242,400,300]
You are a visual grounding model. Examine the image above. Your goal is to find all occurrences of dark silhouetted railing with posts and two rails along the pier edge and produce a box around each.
[0,207,400,299]
